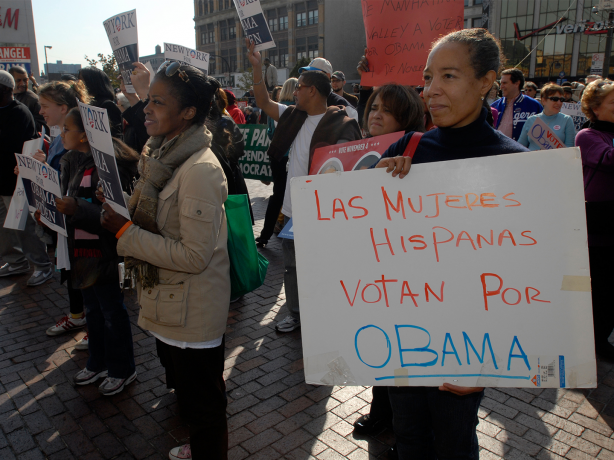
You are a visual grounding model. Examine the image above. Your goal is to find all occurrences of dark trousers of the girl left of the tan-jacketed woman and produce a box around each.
[81,283,135,379]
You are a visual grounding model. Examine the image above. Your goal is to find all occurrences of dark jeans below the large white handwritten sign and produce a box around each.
[388,387,484,460]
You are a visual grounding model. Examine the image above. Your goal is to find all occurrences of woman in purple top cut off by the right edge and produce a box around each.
[576,79,614,359]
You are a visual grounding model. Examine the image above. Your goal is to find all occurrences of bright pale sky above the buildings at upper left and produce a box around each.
[32,0,196,71]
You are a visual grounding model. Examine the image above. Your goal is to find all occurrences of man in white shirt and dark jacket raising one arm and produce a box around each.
[245,39,362,332]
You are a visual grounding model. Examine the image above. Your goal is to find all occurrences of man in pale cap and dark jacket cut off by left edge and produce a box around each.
[0,70,53,286]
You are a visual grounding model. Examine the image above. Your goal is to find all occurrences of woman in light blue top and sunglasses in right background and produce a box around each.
[518,83,576,150]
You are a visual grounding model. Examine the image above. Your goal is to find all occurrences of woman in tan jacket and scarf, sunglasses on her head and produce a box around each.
[102,62,230,459]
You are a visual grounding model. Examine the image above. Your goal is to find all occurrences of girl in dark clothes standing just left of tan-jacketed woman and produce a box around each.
[56,107,138,396]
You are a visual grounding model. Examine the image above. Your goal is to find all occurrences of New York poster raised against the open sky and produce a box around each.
[102,10,139,93]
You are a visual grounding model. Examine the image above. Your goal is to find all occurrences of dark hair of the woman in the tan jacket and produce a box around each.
[154,65,221,125]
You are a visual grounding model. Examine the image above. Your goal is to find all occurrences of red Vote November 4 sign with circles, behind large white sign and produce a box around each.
[309,131,405,178]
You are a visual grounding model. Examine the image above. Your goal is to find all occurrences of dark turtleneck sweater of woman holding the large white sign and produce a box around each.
[382,109,529,164]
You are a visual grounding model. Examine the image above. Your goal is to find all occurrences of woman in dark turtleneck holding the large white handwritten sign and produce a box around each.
[376,29,527,460]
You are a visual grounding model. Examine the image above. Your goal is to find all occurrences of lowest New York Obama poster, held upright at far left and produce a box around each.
[15,153,67,236]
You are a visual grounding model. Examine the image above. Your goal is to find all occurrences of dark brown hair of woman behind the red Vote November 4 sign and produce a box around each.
[363,83,424,132]
